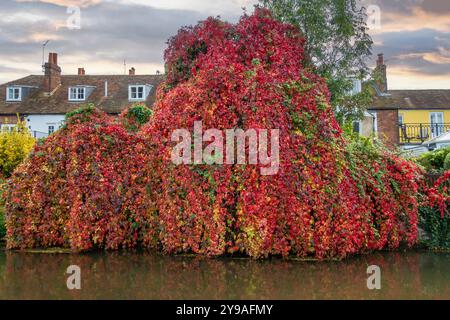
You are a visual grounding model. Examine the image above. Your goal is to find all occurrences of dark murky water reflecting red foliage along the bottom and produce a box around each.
[0,251,450,299]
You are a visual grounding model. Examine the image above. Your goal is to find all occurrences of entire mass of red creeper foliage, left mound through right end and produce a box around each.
[7,9,419,259]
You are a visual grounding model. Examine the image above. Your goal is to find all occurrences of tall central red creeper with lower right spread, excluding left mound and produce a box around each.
[143,10,419,259]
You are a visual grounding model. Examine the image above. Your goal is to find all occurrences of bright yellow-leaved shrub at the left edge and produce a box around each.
[0,117,35,177]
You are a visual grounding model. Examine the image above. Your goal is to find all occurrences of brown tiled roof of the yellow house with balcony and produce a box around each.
[369,90,450,110]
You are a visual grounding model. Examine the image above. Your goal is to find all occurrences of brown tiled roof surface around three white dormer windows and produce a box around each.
[0,75,164,115]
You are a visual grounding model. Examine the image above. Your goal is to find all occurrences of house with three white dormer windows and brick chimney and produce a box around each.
[0,53,164,137]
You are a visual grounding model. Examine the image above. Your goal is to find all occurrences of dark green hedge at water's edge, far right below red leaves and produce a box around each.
[419,207,450,250]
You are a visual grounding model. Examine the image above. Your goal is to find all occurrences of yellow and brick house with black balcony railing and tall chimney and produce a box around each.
[368,54,450,149]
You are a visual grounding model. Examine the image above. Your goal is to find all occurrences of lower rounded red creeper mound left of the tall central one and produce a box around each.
[6,106,156,251]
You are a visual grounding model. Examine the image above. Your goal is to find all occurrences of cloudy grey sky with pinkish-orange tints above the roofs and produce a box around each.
[0,0,450,89]
